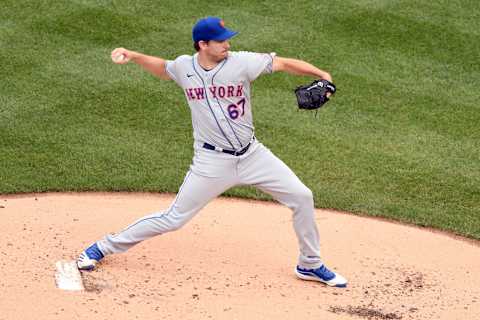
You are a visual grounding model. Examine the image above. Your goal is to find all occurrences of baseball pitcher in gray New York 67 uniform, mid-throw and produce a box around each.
[77,17,347,287]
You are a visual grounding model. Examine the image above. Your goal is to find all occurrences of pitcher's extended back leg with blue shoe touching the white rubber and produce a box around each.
[77,149,238,270]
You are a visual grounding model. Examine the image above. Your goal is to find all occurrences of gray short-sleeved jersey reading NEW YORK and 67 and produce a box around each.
[166,51,275,150]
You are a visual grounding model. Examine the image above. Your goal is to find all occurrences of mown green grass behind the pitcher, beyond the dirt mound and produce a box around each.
[0,0,480,239]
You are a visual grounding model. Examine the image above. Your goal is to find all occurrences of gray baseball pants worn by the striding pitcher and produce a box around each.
[97,140,322,269]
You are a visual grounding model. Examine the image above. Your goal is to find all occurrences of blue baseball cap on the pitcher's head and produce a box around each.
[192,17,238,42]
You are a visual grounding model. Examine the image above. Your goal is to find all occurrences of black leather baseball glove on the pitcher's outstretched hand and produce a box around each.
[295,79,337,110]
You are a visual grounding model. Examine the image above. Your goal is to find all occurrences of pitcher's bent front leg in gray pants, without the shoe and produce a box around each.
[239,145,322,269]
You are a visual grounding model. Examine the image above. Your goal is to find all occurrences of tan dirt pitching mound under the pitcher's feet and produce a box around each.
[0,193,480,320]
